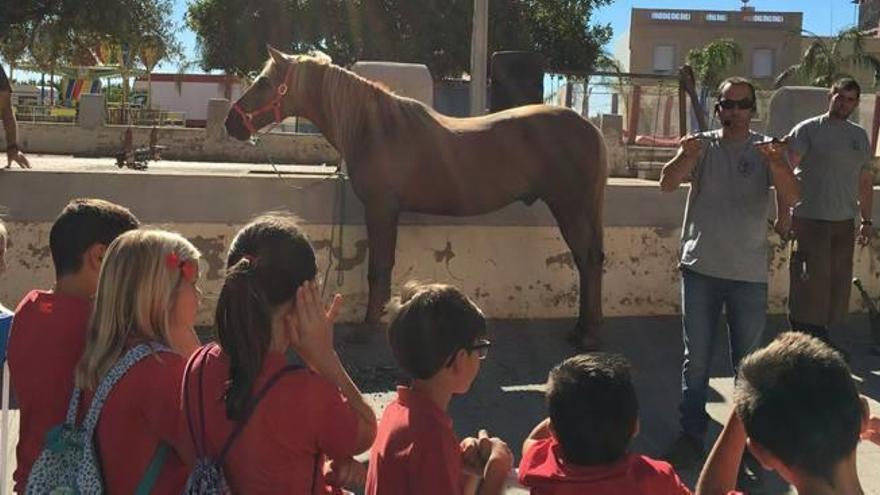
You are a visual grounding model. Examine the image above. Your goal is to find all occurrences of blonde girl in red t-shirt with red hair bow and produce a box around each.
[76,230,200,494]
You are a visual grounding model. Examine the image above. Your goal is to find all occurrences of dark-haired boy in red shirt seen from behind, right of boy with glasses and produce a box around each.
[519,353,690,495]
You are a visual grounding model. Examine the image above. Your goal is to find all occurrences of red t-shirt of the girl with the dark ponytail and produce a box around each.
[184,344,358,495]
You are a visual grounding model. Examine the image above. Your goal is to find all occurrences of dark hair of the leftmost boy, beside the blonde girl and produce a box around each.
[49,198,140,277]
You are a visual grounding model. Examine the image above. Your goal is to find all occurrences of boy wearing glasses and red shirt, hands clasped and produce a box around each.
[366,284,513,495]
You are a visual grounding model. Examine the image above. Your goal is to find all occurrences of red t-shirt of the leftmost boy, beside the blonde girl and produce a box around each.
[8,290,92,492]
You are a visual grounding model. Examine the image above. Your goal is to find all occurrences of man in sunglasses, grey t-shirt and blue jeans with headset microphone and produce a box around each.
[660,78,800,469]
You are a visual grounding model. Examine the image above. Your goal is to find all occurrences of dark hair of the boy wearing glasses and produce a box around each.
[388,282,486,380]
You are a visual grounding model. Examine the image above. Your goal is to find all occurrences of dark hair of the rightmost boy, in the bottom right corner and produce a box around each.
[735,332,862,479]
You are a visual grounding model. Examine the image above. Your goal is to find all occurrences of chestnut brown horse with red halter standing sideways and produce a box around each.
[225,47,607,349]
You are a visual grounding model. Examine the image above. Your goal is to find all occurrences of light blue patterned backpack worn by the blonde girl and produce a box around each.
[25,344,169,495]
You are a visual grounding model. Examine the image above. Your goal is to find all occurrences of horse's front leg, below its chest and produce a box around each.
[364,204,399,329]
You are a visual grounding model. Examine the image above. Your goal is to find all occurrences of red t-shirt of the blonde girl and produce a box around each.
[79,352,190,494]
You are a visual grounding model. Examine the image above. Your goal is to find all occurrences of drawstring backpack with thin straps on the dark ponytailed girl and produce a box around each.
[183,344,302,495]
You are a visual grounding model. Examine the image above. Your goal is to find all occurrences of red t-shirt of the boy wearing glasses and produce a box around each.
[366,387,462,495]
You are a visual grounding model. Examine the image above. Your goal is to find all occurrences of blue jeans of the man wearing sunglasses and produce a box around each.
[679,268,767,438]
